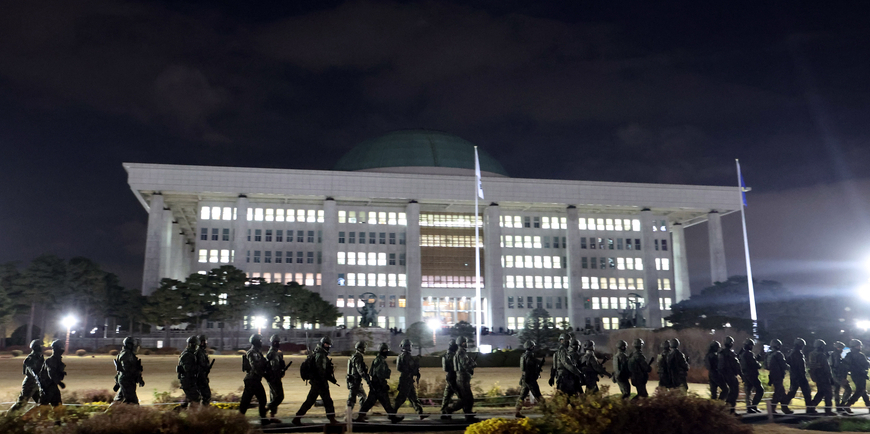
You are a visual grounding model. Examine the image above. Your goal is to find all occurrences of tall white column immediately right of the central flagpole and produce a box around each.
[483,203,507,331]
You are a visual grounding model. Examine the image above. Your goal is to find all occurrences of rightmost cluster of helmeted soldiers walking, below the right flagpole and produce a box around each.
[704,336,870,416]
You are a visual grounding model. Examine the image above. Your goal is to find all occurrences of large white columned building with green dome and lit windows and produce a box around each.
[124,130,741,331]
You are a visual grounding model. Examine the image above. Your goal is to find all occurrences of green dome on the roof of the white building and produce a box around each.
[335,130,508,176]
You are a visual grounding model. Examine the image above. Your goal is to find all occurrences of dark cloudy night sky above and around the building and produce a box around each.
[0,0,870,292]
